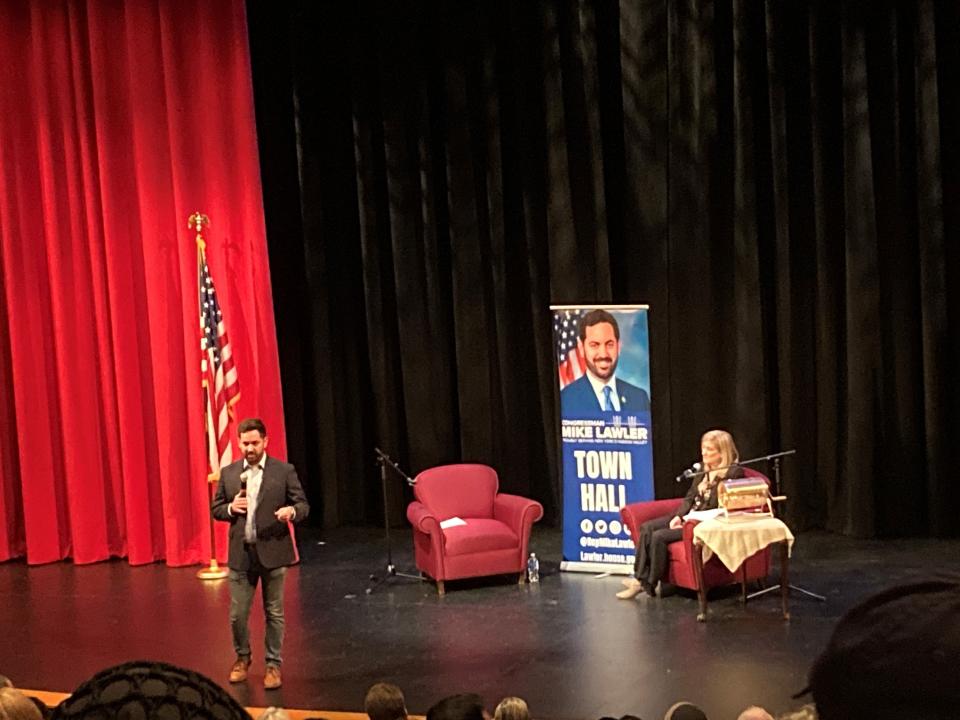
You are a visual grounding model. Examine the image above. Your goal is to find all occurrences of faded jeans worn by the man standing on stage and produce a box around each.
[230,547,287,667]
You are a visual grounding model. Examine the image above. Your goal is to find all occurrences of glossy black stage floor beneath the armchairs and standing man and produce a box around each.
[0,529,960,720]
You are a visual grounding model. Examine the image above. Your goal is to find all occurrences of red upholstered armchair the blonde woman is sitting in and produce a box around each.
[620,468,770,598]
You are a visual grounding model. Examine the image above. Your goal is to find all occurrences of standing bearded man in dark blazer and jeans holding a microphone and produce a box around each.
[211,418,310,690]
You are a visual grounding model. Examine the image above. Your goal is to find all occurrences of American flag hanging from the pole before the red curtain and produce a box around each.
[197,245,240,473]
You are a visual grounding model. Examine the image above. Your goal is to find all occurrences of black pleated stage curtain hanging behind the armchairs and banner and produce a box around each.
[248,0,960,536]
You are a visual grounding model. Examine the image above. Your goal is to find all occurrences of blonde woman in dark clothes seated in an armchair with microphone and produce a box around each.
[617,430,743,600]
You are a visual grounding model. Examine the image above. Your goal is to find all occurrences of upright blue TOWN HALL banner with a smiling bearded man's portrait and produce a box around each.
[550,305,653,572]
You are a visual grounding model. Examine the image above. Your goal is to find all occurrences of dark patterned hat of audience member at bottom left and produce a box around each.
[52,660,250,720]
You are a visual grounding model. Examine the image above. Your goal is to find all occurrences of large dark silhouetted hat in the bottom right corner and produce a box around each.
[800,579,960,720]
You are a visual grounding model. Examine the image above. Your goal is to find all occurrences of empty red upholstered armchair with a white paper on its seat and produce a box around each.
[407,464,543,595]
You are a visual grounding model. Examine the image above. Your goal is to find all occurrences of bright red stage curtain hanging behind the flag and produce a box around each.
[0,0,286,565]
